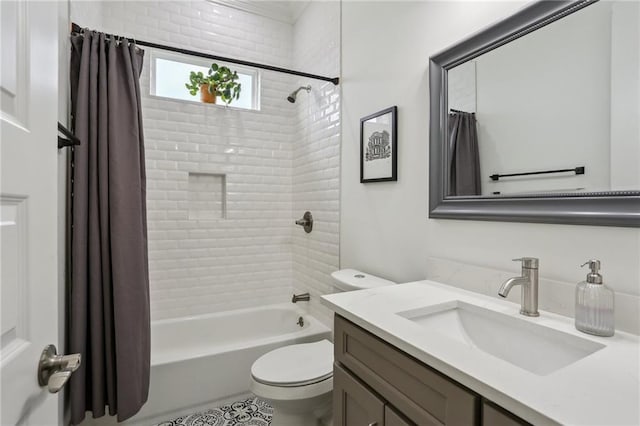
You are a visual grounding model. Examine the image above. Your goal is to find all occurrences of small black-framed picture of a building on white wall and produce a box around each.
[360,106,398,183]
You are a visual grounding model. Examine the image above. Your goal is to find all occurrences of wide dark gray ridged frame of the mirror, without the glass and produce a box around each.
[429,0,640,227]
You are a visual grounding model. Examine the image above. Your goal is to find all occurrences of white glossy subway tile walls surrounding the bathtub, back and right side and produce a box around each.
[71,0,340,320]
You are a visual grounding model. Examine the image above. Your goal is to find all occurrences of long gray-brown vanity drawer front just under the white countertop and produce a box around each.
[334,315,480,426]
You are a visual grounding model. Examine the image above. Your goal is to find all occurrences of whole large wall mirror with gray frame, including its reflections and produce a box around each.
[429,0,640,227]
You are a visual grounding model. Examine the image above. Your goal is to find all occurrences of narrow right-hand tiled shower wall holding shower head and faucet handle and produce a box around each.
[292,2,340,326]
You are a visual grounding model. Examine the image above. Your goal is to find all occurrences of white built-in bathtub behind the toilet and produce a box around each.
[83,303,331,425]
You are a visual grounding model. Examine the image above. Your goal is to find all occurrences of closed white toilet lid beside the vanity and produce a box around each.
[251,340,333,386]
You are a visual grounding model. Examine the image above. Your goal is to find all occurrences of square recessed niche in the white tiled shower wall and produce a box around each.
[189,173,227,219]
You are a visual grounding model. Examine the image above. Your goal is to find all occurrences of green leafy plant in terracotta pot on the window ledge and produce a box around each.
[185,62,242,105]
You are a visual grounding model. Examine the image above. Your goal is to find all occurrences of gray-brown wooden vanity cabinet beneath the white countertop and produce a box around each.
[334,315,527,426]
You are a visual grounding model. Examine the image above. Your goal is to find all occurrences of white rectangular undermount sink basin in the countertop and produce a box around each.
[397,300,605,376]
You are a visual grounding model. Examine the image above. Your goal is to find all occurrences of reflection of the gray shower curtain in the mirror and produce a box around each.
[447,111,482,196]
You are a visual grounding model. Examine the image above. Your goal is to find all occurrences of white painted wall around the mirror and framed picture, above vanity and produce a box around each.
[340,1,640,333]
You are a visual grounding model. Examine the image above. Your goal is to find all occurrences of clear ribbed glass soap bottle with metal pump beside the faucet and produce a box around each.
[575,260,615,336]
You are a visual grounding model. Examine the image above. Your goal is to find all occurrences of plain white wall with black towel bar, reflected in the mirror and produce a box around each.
[475,2,612,195]
